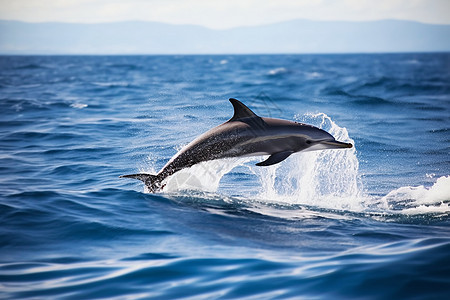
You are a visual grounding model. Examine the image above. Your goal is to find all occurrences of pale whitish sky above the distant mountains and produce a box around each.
[0,0,450,29]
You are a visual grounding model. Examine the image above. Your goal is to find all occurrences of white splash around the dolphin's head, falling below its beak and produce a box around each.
[253,113,364,211]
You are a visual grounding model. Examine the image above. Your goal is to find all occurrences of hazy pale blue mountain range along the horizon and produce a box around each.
[0,20,450,54]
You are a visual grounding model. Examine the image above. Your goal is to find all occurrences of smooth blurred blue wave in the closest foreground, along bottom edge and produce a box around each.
[0,238,450,299]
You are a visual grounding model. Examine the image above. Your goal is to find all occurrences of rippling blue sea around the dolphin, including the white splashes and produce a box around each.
[0,53,450,299]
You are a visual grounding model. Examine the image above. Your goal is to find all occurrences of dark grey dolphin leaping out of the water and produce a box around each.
[120,98,353,193]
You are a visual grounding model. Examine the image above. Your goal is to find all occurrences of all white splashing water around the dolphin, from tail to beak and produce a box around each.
[160,114,363,210]
